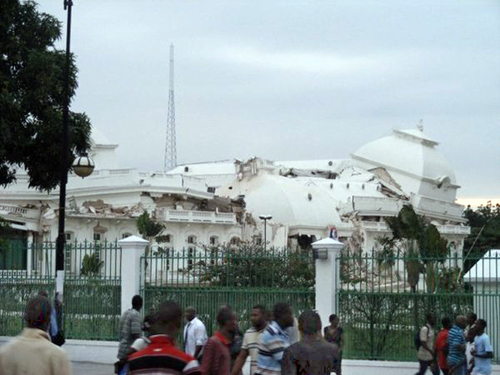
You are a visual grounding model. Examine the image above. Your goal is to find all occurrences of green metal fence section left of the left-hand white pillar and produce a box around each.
[0,242,122,340]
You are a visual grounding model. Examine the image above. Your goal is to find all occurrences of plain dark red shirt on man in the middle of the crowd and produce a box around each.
[201,332,231,375]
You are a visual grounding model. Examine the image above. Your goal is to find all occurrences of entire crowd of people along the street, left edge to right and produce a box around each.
[0,292,493,375]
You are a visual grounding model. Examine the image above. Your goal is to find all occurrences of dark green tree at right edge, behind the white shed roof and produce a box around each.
[464,201,500,273]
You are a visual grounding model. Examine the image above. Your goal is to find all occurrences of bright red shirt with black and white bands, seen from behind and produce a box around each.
[128,335,201,375]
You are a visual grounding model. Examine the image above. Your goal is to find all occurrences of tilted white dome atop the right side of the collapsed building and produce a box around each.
[351,128,456,185]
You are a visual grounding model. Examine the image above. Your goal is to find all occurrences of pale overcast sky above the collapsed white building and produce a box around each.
[40,0,500,206]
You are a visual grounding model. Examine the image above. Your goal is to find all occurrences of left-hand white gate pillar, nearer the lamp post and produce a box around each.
[118,236,149,314]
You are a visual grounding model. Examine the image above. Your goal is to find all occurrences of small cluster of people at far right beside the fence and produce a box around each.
[416,313,493,375]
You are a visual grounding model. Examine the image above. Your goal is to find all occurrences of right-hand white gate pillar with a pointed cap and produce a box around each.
[312,238,344,327]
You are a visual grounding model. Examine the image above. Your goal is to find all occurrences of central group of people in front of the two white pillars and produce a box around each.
[115,295,344,375]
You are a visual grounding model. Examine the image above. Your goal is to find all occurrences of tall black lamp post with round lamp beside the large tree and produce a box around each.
[56,0,94,327]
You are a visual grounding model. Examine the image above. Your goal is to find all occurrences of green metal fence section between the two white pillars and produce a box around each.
[141,246,315,342]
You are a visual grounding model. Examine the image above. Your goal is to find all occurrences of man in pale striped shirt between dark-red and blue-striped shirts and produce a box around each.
[231,305,267,375]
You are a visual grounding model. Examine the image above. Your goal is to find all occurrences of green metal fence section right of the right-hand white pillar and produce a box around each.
[337,251,500,362]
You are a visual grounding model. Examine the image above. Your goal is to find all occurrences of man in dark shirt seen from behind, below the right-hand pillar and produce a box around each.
[281,310,340,375]
